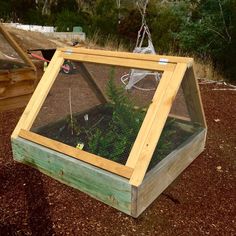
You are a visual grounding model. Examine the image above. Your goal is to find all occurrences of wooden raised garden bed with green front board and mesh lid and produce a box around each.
[12,49,206,217]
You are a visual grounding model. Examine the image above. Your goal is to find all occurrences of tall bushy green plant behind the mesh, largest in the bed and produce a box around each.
[88,71,144,162]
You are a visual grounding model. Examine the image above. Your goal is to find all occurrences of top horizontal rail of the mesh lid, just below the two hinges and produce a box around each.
[62,52,175,71]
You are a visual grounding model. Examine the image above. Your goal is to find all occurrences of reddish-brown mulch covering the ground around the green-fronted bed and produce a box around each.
[0,81,236,235]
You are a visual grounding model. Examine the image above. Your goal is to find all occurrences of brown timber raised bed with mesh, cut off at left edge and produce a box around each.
[0,24,38,112]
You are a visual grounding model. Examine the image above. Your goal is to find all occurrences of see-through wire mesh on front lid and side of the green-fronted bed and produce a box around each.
[31,61,203,170]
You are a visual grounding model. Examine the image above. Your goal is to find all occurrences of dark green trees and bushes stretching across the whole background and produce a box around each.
[0,0,236,79]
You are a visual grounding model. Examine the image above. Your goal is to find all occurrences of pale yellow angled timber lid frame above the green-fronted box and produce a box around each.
[12,48,206,186]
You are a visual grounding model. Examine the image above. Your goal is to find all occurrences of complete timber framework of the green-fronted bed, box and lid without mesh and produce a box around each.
[11,48,207,217]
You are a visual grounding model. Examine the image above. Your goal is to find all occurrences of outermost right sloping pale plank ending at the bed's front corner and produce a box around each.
[130,63,187,186]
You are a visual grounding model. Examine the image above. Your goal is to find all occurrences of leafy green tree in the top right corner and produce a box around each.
[174,0,236,79]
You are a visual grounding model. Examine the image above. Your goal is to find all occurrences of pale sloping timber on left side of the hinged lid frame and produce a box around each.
[12,51,64,138]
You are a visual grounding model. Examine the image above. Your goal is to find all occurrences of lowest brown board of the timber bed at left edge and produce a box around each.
[0,94,32,112]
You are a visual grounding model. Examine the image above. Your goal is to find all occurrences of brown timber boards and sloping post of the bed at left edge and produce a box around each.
[0,24,38,112]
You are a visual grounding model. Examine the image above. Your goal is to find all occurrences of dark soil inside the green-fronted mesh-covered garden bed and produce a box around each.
[31,105,197,170]
